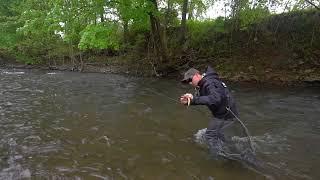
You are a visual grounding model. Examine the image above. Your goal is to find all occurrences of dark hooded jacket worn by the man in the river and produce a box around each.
[191,66,238,119]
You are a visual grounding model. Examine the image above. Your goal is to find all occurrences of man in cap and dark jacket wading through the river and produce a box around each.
[180,66,254,160]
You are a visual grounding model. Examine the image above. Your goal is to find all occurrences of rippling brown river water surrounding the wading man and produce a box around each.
[0,69,320,180]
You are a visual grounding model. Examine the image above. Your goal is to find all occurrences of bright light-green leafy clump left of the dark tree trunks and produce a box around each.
[78,23,120,50]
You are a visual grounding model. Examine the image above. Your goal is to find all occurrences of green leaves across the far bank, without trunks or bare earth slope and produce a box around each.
[0,0,320,69]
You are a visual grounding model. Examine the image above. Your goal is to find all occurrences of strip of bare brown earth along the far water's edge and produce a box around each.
[0,56,320,86]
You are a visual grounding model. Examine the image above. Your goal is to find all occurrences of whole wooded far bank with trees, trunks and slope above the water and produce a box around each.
[0,0,320,81]
